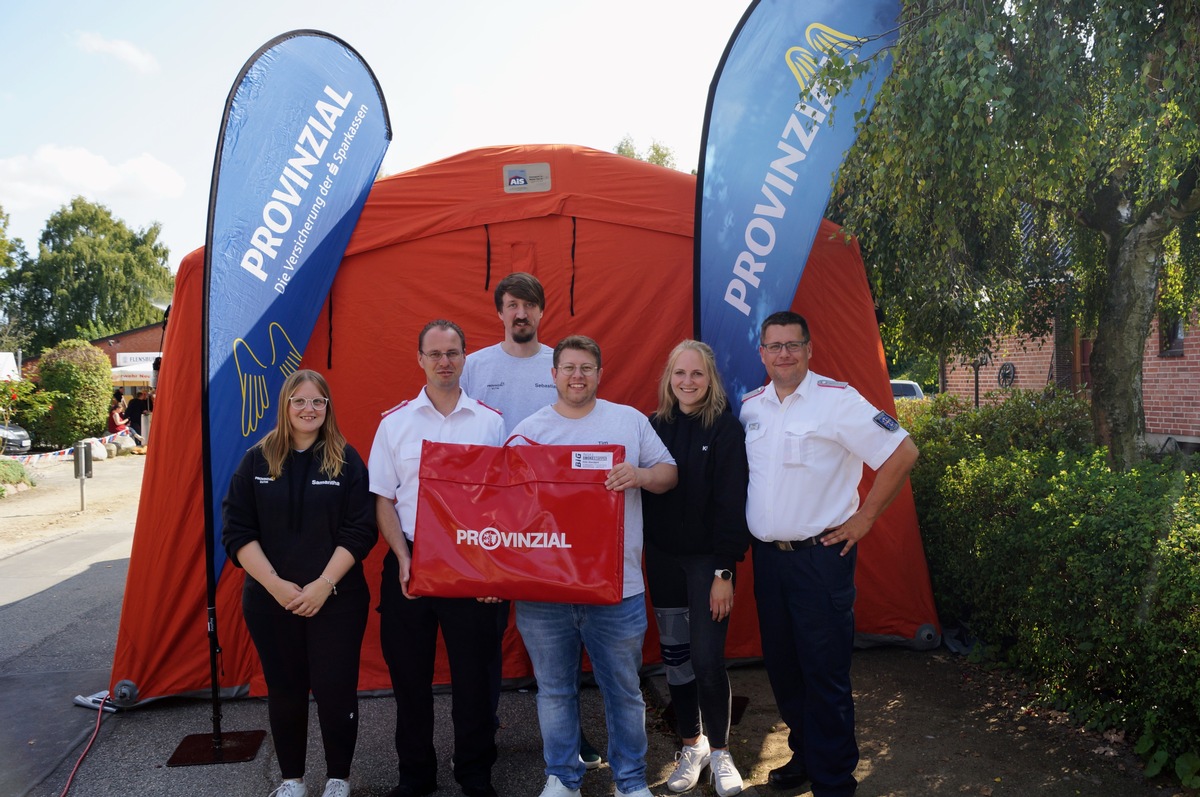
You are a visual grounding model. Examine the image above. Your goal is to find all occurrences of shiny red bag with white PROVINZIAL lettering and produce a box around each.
[408,438,625,604]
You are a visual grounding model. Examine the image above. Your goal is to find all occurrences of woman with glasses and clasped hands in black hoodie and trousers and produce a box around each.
[222,371,377,797]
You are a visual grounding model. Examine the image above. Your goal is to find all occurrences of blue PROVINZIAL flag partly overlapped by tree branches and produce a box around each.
[694,0,900,400]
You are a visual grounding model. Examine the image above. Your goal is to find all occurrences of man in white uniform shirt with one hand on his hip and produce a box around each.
[740,312,917,797]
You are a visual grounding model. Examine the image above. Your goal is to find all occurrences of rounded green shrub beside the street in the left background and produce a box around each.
[29,341,113,448]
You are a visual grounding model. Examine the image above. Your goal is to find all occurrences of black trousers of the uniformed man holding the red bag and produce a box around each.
[379,553,499,791]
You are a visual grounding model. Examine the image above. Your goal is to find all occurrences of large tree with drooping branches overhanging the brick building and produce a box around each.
[822,0,1200,468]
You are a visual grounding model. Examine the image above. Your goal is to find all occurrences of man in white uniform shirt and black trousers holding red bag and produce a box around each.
[367,320,504,797]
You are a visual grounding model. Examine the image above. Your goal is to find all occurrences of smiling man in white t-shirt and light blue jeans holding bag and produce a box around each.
[514,335,678,797]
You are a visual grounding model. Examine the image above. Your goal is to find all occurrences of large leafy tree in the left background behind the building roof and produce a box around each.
[6,197,174,350]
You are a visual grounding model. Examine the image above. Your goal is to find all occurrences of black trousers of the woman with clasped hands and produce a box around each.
[242,591,371,780]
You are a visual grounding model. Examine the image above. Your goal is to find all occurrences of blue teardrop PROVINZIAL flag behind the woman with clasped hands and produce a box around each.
[203,31,391,577]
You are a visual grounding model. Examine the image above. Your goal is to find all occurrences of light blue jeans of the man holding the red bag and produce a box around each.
[515,595,647,795]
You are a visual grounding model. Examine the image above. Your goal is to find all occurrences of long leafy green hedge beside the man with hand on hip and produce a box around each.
[899,394,1200,787]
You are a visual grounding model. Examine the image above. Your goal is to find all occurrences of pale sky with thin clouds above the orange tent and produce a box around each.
[0,0,749,270]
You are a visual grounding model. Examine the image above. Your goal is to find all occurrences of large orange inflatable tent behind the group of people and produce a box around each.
[110,145,940,700]
